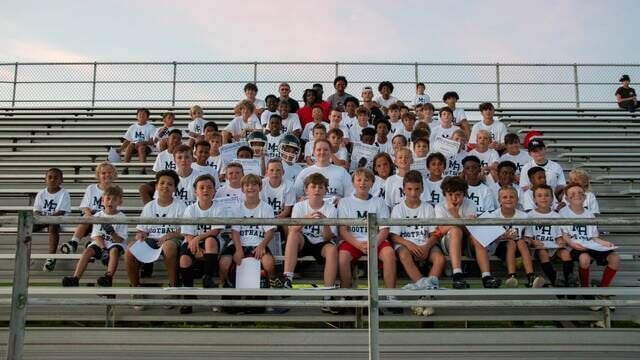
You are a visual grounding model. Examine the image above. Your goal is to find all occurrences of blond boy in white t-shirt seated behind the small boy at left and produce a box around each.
[60,161,118,254]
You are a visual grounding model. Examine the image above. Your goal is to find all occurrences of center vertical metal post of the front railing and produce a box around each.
[367,213,380,360]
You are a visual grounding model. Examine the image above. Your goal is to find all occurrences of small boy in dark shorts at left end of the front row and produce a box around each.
[62,185,128,287]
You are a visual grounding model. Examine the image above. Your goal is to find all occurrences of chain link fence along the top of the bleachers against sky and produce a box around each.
[0,62,640,108]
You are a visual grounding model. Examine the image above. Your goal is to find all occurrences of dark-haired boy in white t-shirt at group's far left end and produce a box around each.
[33,168,71,271]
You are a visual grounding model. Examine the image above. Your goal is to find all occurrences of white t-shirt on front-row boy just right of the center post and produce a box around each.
[389,201,436,245]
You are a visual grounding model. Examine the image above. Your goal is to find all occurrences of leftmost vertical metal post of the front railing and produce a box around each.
[6,211,33,360]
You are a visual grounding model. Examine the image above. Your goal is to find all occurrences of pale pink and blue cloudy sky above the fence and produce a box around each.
[0,0,640,62]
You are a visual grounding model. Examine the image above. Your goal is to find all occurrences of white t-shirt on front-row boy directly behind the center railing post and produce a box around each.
[338,195,389,241]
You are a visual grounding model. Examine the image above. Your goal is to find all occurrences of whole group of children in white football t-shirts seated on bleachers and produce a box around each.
[34,79,619,314]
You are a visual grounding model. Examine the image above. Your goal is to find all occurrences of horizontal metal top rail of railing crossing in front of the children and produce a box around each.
[29,213,640,226]
